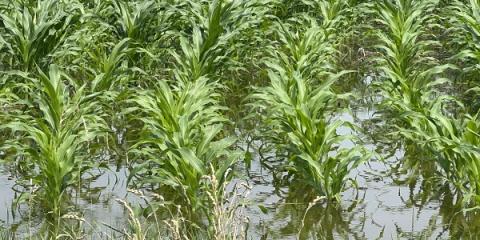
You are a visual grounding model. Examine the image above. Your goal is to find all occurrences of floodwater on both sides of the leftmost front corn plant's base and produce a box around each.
[0,167,130,239]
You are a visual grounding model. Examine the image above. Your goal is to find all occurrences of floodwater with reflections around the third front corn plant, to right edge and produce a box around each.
[240,108,480,239]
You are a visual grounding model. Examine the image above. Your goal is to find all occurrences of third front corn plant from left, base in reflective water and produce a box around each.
[256,68,368,200]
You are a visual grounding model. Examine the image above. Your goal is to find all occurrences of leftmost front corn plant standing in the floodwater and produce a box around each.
[3,65,105,217]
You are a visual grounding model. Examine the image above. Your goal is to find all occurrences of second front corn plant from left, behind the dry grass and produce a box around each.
[132,78,238,218]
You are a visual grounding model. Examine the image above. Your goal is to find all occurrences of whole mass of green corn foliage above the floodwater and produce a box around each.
[4,0,480,239]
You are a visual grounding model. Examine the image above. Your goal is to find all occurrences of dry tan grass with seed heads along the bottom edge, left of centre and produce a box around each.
[117,175,251,240]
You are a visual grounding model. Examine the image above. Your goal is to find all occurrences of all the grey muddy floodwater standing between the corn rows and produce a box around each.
[0,110,480,239]
